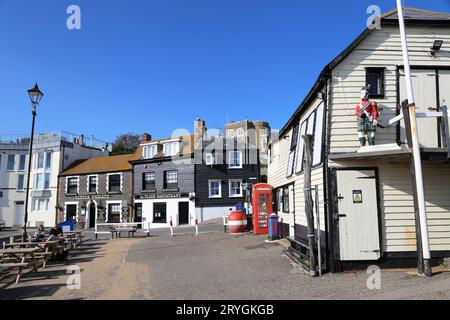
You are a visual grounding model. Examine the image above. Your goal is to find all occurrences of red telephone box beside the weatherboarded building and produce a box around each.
[252,183,273,234]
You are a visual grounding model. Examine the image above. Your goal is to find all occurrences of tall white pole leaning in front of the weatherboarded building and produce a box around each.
[397,0,431,277]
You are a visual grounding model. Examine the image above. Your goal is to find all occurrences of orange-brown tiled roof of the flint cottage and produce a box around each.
[61,148,142,176]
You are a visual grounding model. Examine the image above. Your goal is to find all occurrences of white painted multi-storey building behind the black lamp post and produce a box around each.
[0,132,109,227]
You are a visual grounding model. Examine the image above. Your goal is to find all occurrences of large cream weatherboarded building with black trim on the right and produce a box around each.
[268,8,450,272]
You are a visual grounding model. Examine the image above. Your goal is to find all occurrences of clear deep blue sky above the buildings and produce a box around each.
[0,0,450,140]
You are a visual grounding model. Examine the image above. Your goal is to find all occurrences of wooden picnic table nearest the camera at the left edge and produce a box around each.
[0,248,40,284]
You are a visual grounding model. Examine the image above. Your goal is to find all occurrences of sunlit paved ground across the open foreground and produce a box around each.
[0,220,450,300]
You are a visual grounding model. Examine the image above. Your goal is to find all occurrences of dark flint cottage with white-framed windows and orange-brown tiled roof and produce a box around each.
[58,149,141,229]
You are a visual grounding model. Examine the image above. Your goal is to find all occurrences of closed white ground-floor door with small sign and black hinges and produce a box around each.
[337,170,381,261]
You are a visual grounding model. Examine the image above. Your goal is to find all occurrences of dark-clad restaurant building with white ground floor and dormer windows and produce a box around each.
[131,134,196,229]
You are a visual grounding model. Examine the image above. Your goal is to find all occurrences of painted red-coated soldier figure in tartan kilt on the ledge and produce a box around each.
[356,87,378,147]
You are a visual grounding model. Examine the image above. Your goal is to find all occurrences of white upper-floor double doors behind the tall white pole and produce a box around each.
[400,70,439,148]
